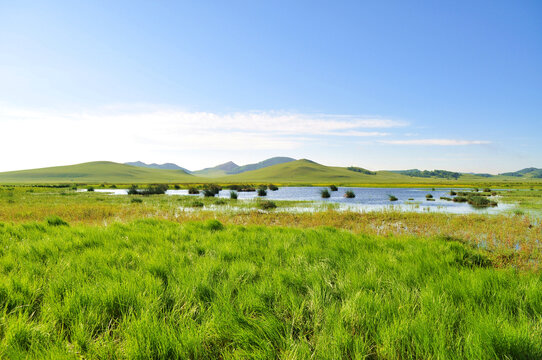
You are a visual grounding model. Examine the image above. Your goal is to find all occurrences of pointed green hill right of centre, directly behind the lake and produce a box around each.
[217,159,408,184]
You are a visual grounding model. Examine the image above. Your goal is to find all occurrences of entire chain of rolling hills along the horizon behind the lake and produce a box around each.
[0,158,541,186]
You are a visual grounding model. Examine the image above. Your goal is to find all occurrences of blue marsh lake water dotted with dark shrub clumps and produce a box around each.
[89,186,513,214]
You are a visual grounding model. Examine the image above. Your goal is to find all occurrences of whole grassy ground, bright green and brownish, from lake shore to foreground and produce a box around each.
[0,185,542,359]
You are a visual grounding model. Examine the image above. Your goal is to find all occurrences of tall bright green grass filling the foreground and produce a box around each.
[0,220,542,359]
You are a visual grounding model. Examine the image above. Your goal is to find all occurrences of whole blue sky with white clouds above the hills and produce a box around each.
[0,0,542,173]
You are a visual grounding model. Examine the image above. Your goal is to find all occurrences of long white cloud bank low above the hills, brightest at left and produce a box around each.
[0,104,407,171]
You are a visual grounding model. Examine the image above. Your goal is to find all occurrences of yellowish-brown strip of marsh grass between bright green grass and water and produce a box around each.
[0,187,542,270]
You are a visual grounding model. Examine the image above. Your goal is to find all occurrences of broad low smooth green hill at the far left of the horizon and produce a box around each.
[0,161,201,184]
